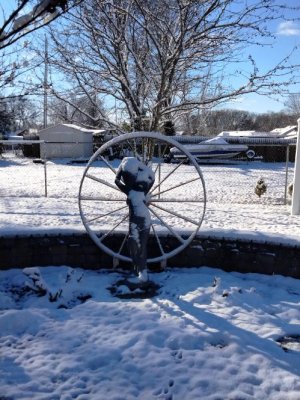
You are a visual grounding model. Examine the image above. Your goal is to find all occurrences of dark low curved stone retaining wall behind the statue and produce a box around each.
[0,234,300,278]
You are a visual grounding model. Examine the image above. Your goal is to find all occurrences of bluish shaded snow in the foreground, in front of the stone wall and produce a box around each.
[0,267,300,400]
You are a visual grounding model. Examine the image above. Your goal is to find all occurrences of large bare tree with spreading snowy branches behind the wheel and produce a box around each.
[47,0,296,130]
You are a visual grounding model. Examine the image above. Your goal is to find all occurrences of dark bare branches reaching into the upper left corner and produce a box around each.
[0,0,81,102]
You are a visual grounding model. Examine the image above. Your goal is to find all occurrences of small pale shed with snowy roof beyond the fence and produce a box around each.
[38,124,95,159]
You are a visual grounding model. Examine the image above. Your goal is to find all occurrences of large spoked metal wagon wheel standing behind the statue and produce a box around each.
[78,132,206,263]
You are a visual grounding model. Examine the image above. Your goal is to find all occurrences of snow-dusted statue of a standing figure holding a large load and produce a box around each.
[115,157,155,283]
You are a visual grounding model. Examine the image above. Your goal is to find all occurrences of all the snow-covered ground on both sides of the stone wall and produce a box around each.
[0,155,300,400]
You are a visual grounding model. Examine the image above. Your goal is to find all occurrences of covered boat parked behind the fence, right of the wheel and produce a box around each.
[168,137,251,161]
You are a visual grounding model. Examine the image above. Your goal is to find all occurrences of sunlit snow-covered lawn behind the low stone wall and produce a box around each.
[0,158,300,243]
